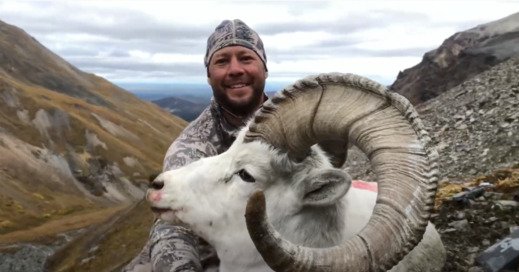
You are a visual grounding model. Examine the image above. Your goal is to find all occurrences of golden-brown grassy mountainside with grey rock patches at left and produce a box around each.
[0,21,186,238]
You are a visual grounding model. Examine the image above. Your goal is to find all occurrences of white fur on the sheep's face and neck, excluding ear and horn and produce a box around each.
[148,131,444,272]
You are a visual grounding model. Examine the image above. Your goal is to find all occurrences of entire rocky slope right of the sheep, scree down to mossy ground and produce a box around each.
[346,55,519,272]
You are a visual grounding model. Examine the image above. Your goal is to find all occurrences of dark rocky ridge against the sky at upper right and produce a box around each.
[390,13,519,105]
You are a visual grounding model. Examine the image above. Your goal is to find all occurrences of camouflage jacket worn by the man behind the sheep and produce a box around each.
[123,100,244,272]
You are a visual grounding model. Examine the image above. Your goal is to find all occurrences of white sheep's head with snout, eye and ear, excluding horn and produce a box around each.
[148,132,351,257]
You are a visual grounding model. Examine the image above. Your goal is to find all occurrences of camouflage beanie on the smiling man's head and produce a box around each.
[204,19,267,70]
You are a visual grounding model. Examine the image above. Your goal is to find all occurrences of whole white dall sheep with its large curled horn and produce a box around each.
[148,74,445,272]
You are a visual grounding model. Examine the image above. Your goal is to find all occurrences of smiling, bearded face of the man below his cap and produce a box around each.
[208,46,267,115]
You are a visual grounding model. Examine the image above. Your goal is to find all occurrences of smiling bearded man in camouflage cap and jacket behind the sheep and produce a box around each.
[123,19,268,272]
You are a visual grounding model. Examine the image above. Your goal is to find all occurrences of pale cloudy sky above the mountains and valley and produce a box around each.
[0,0,519,87]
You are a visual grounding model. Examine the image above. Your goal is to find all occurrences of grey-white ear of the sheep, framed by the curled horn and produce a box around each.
[302,169,351,207]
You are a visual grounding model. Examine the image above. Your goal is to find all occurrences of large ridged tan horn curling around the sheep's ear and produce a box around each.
[245,73,438,271]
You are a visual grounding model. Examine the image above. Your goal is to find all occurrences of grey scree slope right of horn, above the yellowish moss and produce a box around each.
[417,58,519,180]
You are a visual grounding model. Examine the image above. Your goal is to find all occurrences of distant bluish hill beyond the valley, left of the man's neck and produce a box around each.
[152,96,209,122]
